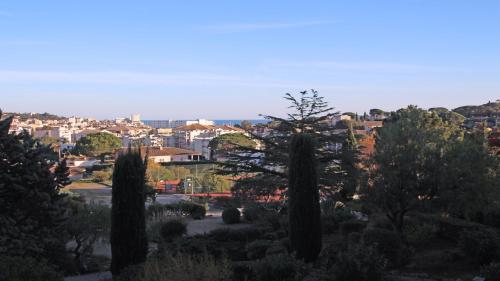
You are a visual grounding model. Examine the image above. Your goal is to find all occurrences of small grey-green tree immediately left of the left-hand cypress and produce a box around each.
[65,198,111,273]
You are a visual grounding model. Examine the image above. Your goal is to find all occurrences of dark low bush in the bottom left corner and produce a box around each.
[0,256,63,281]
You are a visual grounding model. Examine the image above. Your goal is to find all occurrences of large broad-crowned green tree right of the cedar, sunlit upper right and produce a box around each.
[371,106,460,233]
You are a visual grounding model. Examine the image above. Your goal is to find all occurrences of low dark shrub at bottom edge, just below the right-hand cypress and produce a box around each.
[252,255,307,281]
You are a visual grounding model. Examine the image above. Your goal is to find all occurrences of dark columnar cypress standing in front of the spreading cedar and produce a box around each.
[288,134,321,262]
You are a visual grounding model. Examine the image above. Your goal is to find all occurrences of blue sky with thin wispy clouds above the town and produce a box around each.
[0,0,500,119]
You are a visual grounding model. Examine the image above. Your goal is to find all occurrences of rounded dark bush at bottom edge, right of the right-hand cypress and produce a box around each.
[332,245,386,281]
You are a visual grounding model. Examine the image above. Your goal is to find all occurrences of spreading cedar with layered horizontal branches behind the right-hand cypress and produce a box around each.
[219,90,345,196]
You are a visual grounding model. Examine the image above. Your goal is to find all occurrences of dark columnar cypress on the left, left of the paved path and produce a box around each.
[111,148,148,275]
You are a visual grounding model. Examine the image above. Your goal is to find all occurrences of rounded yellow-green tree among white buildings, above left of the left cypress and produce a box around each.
[74,132,122,160]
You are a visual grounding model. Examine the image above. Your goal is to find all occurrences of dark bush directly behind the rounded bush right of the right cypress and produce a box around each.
[363,228,402,265]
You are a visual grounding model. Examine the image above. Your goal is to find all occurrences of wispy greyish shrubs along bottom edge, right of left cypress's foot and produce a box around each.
[118,253,231,281]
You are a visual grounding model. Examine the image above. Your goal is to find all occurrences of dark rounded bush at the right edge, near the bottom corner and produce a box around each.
[458,229,499,264]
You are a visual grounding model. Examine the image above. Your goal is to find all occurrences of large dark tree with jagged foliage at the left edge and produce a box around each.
[0,111,68,262]
